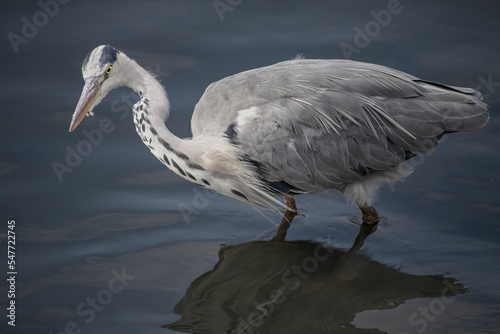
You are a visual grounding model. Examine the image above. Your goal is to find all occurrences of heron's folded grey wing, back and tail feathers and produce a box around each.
[192,60,489,192]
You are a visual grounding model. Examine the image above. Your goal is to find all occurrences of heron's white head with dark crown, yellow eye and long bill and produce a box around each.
[69,45,124,132]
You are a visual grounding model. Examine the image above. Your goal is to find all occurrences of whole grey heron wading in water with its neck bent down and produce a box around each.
[69,45,489,224]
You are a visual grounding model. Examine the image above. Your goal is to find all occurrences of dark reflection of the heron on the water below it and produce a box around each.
[164,224,465,334]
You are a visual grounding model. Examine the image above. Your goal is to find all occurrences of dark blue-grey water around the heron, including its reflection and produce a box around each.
[0,0,500,334]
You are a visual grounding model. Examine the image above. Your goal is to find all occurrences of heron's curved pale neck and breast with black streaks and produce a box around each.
[117,54,283,211]
